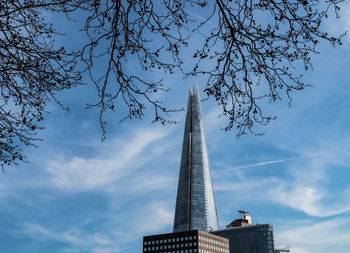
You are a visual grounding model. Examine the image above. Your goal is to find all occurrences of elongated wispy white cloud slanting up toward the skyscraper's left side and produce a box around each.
[47,129,169,191]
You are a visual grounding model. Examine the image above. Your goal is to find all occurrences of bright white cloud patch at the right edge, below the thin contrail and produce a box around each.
[268,152,350,217]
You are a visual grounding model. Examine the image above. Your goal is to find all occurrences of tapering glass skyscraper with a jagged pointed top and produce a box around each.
[174,86,219,232]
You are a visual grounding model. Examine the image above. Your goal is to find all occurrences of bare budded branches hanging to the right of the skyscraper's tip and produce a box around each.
[187,0,344,137]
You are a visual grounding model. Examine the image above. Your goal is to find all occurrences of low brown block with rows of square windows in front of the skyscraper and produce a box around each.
[143,230,230,253]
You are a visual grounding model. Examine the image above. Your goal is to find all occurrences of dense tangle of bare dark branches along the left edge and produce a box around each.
[0,1,80,169]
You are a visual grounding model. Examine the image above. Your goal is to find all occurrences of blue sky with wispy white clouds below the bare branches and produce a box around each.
[0,3,350,253]
